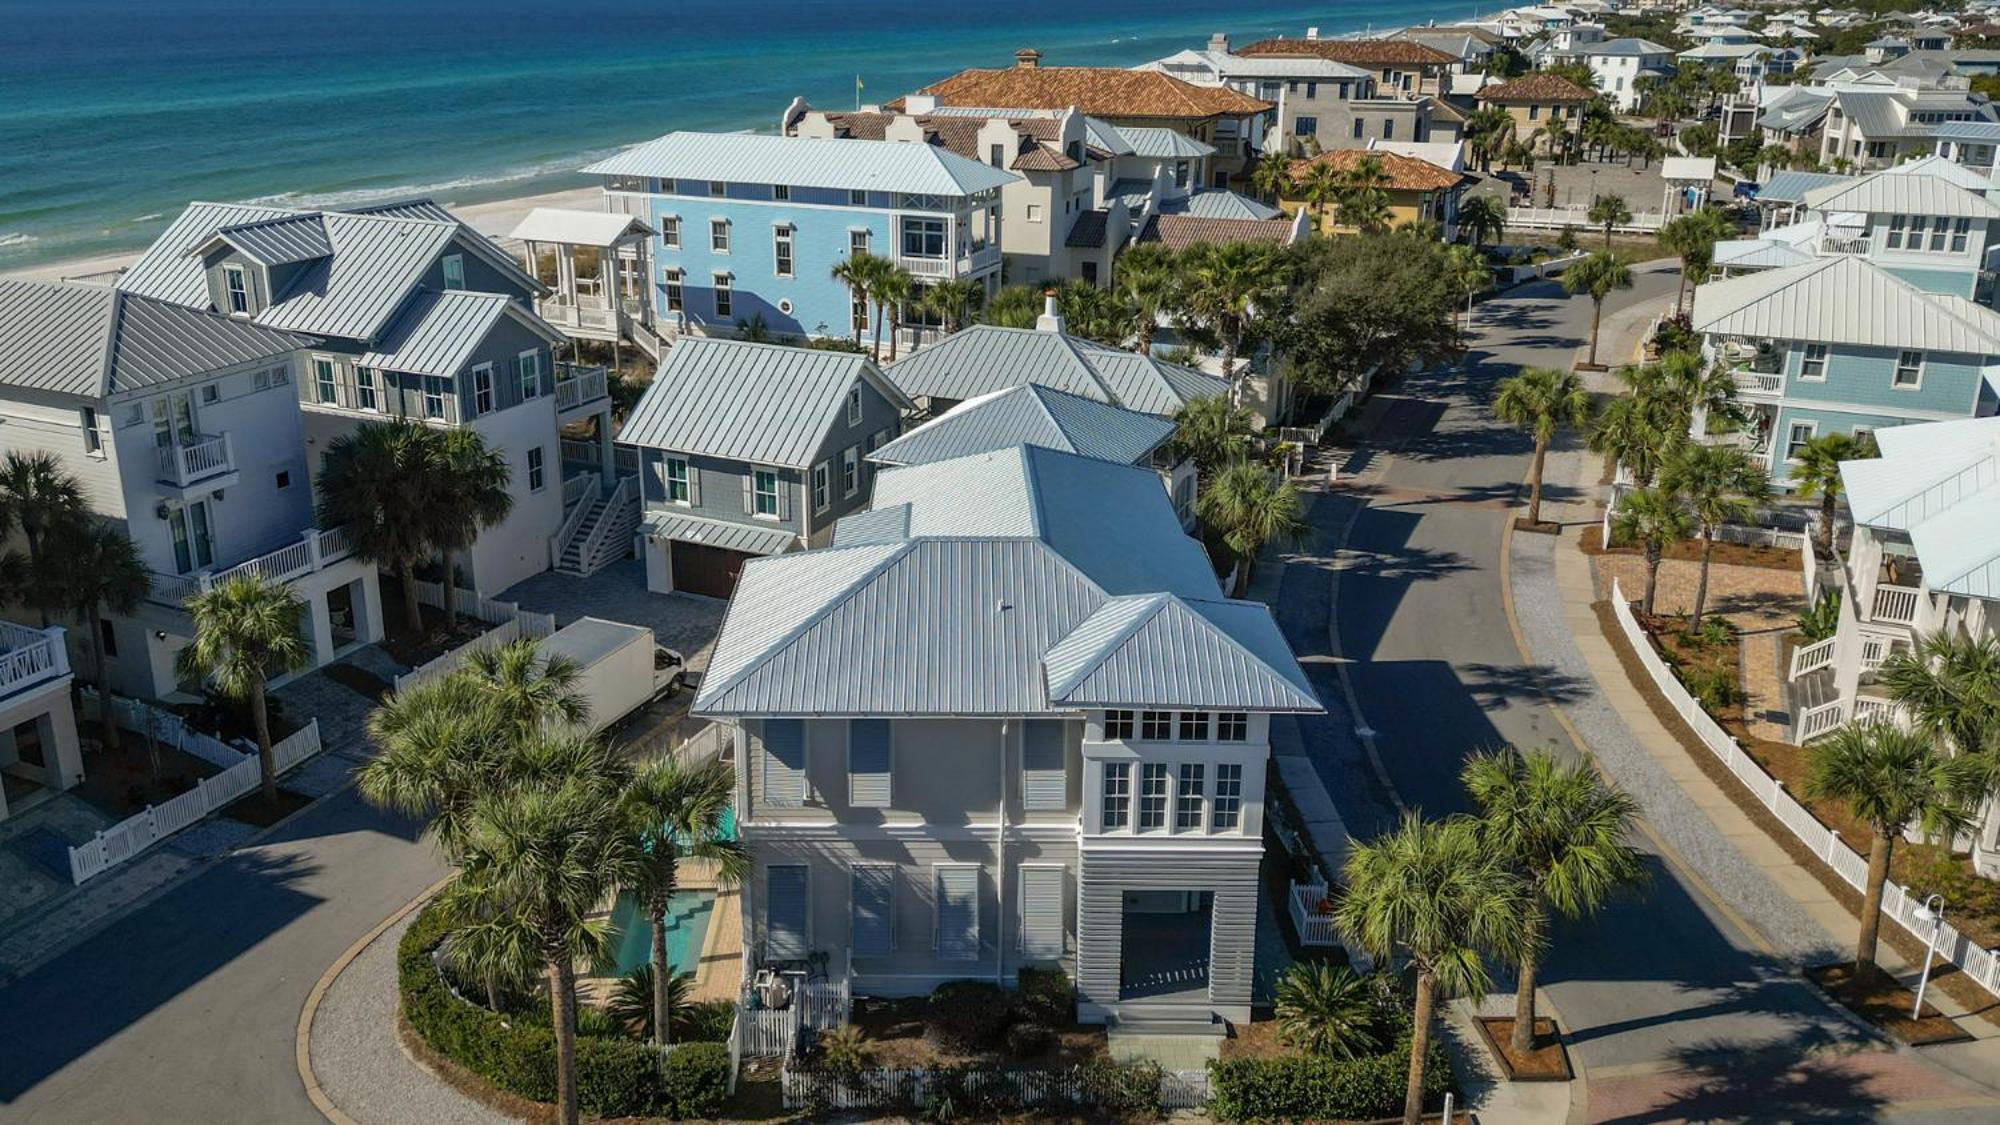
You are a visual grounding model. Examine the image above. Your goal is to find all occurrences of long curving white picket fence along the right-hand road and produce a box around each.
[1612,579,2000,997]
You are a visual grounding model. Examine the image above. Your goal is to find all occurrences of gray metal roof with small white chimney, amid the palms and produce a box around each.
[884,324,1228,414]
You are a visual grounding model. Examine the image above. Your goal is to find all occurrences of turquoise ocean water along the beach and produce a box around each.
[0,0,1476,270]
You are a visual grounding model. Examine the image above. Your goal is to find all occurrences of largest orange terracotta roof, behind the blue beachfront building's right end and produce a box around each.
[908,66,1272,118]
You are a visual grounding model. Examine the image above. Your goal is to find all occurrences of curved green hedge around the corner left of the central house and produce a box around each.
[396,892,730,1117]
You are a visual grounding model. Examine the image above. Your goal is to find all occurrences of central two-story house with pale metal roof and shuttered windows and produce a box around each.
[694,436,1320,1033]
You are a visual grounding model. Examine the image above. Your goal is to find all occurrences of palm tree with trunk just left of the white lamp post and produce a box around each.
[1806,721,1986,973]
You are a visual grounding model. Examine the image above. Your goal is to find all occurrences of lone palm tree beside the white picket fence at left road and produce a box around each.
[180,575,312,811]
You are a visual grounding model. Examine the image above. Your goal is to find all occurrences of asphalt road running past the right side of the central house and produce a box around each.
[1278,272,1976,1121]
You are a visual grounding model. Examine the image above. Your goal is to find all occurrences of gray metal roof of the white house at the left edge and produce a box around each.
[0,278,310,398]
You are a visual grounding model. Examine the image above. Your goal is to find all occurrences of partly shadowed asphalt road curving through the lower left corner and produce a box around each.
[0,776,444,1125]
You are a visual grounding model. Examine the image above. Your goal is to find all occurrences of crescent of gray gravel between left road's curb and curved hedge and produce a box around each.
[312,913,514,1125]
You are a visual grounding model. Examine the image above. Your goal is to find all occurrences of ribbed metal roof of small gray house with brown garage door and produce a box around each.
[618,336,924,468]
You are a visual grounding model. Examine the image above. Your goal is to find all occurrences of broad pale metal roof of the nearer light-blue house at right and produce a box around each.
[1692,254,2000,354]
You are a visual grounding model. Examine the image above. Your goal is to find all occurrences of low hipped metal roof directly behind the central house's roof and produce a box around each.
[868,384,1174,464]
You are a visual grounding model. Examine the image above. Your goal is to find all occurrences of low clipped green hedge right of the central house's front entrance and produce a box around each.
[1208,1041,1452,1121]
